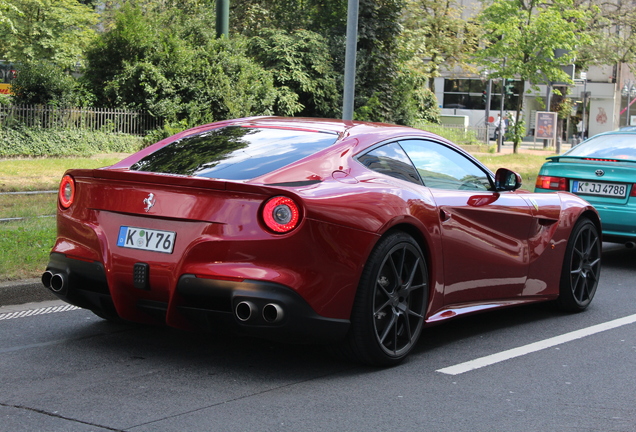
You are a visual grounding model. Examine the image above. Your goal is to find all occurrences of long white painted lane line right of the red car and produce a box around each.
[436,315,636,375]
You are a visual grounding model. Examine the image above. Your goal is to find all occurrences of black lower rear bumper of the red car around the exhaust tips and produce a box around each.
[43,253,349,342]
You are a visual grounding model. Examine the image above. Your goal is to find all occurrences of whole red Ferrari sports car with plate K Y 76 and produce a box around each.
[42,117,601,364]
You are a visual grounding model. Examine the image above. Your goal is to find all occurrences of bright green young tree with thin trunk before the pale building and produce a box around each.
[476,0,589,153]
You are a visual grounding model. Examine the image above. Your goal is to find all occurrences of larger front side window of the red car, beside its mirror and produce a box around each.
[400,139,491,191]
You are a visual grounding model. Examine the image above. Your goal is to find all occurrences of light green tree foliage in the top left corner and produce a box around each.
[0,0,98,68]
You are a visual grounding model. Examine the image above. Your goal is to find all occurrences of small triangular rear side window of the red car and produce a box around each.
[358,143,422,185]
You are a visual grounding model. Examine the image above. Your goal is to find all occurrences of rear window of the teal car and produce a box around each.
[564,133,636,160]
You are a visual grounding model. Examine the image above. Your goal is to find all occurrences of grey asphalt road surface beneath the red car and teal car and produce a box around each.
[0,246,636,432]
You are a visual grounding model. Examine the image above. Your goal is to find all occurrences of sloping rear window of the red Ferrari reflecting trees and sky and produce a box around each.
[130,126,338,180]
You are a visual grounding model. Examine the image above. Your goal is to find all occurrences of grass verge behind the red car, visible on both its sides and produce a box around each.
[0,153,545,281]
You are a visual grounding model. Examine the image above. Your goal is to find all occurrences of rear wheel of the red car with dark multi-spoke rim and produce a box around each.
[344,232,428,366]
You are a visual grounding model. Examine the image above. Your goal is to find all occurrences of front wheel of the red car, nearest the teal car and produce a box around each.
[557,218,601,312]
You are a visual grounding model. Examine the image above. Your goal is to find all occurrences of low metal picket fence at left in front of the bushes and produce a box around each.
[0,105,163,135]
